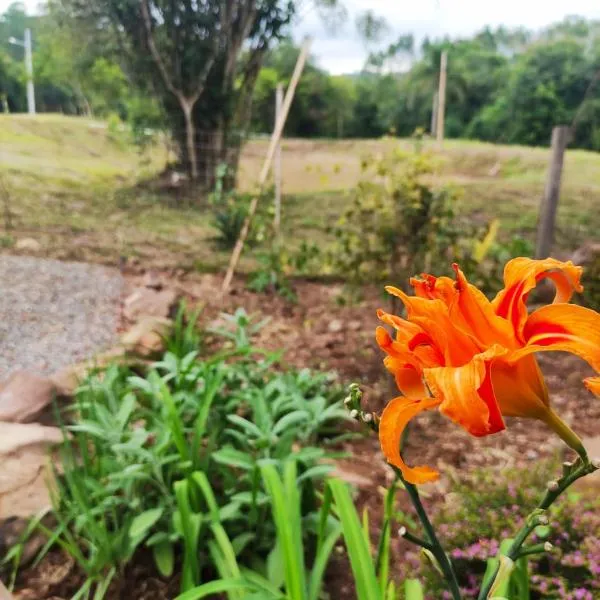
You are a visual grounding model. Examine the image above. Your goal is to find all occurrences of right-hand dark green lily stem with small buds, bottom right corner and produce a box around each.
[478,450,598,600]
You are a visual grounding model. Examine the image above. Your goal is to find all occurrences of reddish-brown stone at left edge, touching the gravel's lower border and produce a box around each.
[0,371,57,423]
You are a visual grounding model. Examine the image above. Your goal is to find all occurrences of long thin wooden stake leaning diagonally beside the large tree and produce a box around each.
[221,38,311,293]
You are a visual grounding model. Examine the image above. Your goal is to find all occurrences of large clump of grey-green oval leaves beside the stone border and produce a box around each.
[29,310,346,599]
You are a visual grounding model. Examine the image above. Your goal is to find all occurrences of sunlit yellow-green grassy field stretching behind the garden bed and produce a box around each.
[0,115,600,269]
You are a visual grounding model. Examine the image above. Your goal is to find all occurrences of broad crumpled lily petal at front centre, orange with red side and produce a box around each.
[423,345,507,437]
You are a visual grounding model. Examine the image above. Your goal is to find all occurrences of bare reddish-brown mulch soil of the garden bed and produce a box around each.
[10,273,600,600]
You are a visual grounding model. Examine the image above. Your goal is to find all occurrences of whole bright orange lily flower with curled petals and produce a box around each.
[376,258,600,484]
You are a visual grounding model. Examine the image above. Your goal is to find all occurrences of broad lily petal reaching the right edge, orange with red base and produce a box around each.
[510,304,600,372]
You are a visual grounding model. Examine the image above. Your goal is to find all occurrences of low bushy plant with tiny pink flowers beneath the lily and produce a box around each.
[407,461,600,600]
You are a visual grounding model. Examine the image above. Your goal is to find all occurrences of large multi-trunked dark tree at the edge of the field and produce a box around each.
[57,0,332,186]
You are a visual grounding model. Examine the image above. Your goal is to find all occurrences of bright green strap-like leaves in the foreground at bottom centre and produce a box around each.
[177,458,424,600]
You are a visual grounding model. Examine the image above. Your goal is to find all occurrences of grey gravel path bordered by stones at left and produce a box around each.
[0,255,123,379]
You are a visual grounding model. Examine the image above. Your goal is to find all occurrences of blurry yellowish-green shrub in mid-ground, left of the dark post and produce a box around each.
[332,148,459,292]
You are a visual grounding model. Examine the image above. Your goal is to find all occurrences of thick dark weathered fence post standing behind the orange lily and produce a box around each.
[535,125,571,258]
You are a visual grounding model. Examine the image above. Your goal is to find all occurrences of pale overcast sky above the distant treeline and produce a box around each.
[0,0,600,73]
